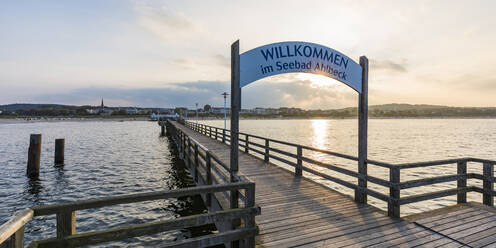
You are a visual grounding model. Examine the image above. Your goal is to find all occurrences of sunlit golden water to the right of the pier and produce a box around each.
[201,119,496,215]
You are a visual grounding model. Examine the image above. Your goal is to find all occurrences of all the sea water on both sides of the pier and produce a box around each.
[0,119,496,247]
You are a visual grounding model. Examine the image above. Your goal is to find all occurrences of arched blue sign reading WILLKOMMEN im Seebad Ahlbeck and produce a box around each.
[240,42,362,93]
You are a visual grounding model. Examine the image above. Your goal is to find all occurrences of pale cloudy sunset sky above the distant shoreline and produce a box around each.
[0,0,496,109]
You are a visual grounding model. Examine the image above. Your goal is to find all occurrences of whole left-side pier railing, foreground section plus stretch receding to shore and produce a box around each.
[0,121,260,248]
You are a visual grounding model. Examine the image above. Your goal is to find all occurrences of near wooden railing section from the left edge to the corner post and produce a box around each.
[0,182,260,248]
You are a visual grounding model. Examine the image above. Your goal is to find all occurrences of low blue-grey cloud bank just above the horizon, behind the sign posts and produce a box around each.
[28,80,357,109]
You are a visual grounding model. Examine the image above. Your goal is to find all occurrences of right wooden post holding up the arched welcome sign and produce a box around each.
[355,56,369,203]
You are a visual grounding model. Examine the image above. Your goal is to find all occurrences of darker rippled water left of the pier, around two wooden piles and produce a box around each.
[0,121,209,247]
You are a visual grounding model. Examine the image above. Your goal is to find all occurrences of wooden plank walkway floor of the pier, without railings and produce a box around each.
[174,123,496,247]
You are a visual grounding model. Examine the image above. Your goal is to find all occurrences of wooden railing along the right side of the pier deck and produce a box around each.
[184,121,496,217]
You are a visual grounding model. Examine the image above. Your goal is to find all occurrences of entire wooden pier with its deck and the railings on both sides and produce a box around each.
[0,120,496,248]
